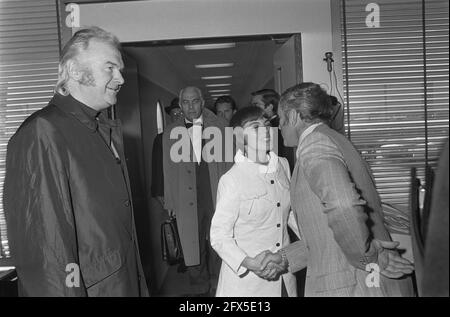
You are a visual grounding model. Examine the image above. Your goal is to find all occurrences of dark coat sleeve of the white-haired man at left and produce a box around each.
[4,122,86,296]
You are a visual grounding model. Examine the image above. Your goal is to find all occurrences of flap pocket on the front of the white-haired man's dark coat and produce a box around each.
[82,250,123,288]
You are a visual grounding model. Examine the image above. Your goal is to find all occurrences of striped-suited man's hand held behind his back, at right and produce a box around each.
[372,239,414,278]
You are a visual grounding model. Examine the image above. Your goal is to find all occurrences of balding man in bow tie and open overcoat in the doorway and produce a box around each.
[163,87,231,296]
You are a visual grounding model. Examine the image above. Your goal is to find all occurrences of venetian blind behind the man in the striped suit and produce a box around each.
[341,0,449,206]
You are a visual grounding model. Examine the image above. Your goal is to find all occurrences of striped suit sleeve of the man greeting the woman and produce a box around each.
[299,132,377,270]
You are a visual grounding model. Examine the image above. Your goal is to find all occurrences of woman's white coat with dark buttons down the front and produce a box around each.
[210,151,297,297]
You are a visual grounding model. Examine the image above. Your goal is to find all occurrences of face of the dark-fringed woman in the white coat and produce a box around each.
[243,118,272,161]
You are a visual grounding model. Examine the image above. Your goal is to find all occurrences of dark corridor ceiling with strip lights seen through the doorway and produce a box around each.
[123,35,289,107]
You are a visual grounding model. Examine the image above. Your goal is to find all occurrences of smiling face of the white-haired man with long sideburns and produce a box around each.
[76,39,124,111]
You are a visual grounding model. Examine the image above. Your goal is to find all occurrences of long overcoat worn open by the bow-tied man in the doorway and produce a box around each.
[163,109,233,266]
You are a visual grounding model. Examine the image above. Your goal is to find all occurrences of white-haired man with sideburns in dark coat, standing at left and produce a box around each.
[4,27,148,296]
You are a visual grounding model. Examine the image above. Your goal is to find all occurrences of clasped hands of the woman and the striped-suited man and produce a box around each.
[242,250,288,281]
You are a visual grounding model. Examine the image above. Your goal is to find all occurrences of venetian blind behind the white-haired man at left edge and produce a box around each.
[0,0,59,260]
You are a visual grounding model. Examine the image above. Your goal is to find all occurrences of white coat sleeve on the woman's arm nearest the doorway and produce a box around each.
[210,175,247,275]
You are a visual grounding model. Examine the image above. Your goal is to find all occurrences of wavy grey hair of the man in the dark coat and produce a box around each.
[55,26,120,96]
